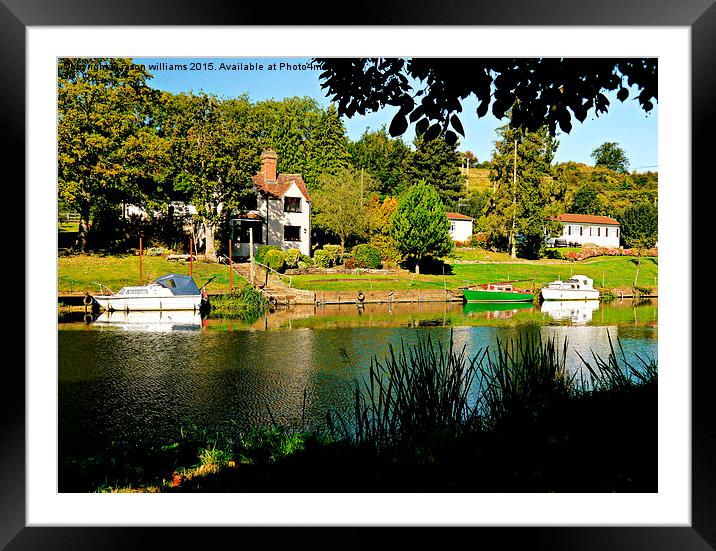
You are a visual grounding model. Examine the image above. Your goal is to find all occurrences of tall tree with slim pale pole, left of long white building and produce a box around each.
[486,126,565,258]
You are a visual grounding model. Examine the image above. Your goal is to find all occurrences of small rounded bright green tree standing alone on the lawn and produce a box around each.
[390,180,453,274]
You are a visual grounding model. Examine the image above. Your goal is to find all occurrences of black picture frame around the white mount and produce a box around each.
[0,0,704,550]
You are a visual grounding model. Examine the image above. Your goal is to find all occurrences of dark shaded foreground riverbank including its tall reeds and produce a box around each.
[72,339,657,493]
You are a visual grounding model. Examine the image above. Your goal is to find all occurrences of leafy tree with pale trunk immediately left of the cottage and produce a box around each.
[165,93,260,259]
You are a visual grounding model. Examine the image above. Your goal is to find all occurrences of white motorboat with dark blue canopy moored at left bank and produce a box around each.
[92,274,202,312]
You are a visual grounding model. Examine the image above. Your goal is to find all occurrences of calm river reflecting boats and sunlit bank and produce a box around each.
[58,300,658,490]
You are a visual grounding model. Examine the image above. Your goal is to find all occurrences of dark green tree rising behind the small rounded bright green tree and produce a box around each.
[403,137,467,209]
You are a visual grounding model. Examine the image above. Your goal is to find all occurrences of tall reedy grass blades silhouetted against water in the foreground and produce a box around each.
[327,335,657,456]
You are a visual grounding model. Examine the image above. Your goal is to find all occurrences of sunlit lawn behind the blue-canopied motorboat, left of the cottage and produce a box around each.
[58,254,244,293]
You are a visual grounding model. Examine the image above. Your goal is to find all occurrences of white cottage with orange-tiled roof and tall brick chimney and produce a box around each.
[232,150,311,257]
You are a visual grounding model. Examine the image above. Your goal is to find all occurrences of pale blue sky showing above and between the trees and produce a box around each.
[134,58,658,172]
